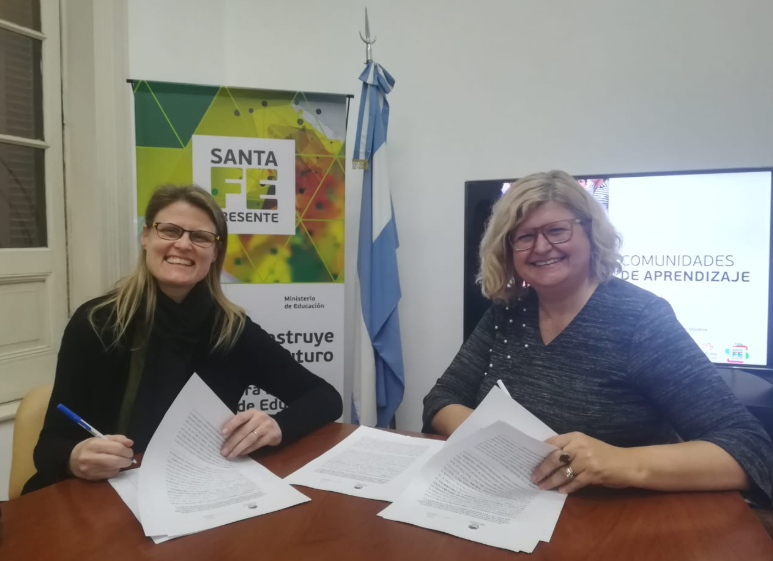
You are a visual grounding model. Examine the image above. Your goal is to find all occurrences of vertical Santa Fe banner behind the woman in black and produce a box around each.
[133,81,348,413]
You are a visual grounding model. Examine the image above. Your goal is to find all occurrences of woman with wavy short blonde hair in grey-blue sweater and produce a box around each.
[424,171,773,501]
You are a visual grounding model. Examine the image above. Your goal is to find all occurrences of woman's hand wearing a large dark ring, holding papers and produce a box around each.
[531,432,638,493]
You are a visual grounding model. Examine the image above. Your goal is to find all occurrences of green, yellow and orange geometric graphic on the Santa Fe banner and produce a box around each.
[134,81,347,283]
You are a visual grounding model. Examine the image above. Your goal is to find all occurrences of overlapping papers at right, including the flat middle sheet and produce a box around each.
[285,386,566,553]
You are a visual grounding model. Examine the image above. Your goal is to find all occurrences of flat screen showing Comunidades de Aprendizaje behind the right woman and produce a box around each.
[464,169,773,369]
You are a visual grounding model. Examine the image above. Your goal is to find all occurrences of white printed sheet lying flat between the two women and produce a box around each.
[285,427,444,501]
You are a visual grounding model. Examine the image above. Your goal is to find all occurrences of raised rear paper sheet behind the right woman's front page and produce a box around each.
[446,386,556,444]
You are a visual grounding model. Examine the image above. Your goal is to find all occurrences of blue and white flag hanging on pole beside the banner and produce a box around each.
[354,62,405,427]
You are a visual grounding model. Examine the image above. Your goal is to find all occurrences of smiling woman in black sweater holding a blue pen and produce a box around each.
[24,185,342,492]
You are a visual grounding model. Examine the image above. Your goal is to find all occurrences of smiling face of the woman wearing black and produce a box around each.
[141,201,217,302]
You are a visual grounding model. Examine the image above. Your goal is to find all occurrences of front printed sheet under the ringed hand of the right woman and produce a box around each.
[379,420,566,552]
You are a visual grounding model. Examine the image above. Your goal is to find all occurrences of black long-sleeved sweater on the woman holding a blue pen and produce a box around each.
[23,284,342,493]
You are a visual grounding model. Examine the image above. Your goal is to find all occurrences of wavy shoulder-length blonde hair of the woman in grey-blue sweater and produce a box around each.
[477,171,622,302]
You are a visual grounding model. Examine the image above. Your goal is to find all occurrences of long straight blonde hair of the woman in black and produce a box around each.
[88,185,245,350]
